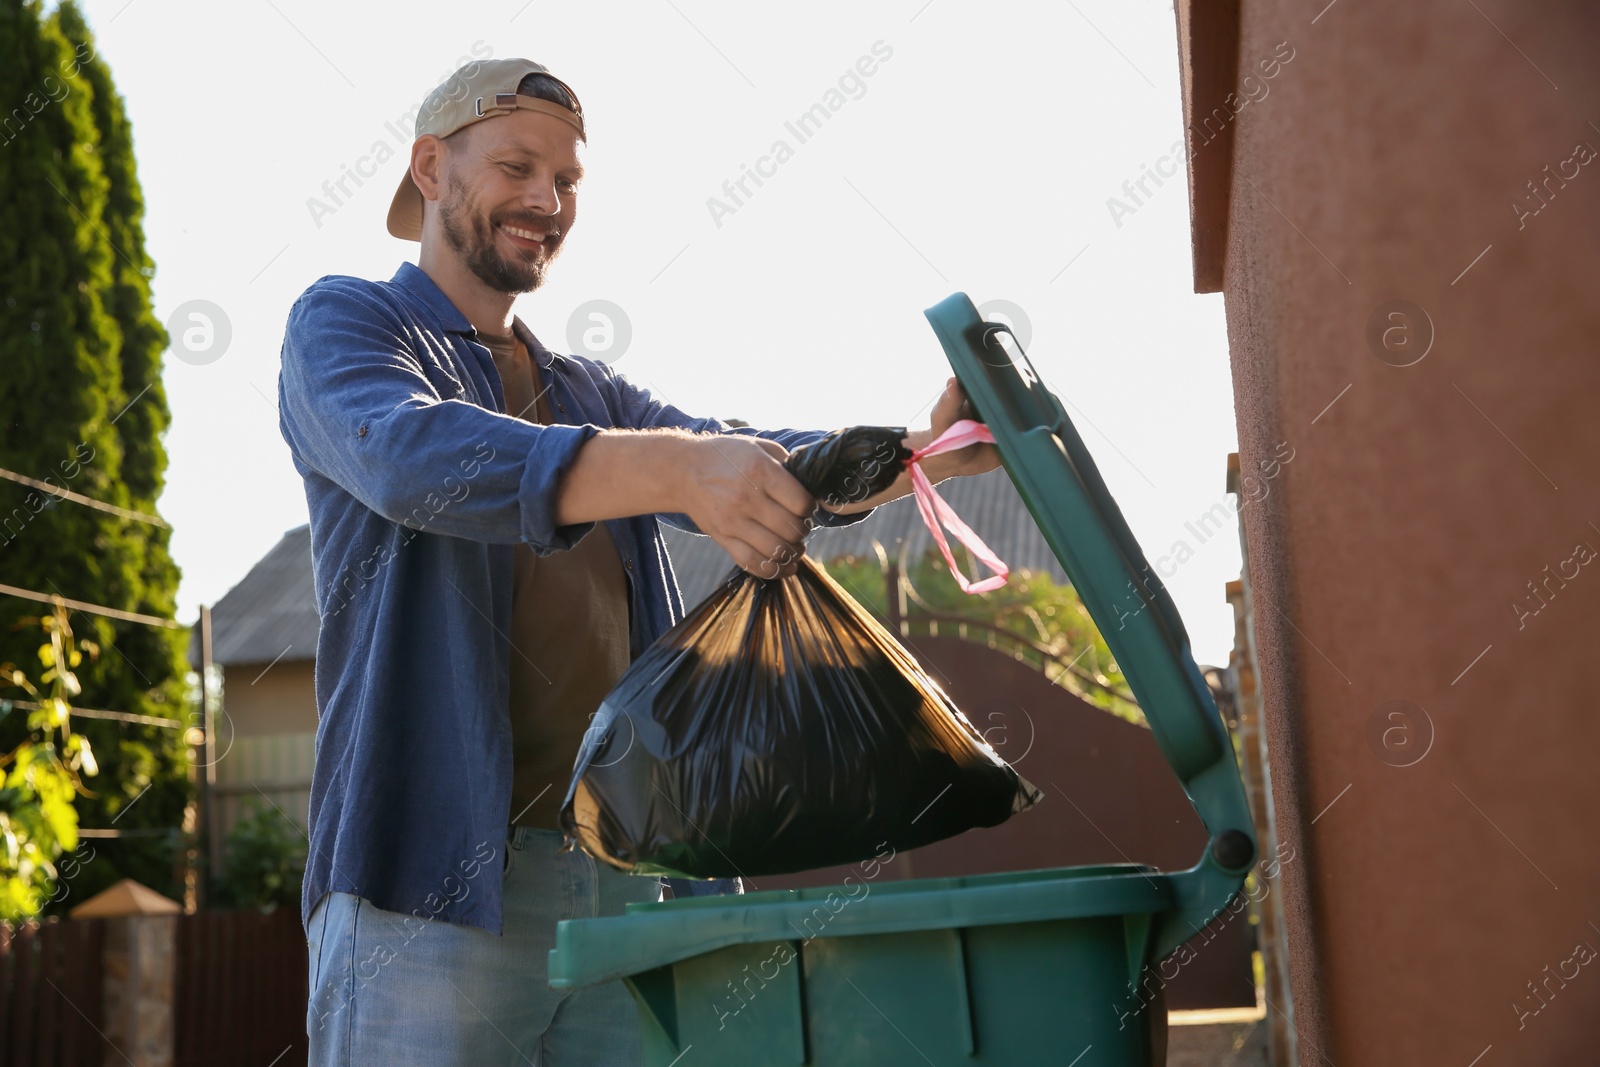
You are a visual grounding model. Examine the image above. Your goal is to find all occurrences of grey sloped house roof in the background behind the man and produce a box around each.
[203,470,1067,665]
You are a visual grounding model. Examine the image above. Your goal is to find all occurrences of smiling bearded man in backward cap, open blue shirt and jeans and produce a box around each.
[278,59,997,1067]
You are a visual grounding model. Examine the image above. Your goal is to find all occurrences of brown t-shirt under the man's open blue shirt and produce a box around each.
[478,331,629,829]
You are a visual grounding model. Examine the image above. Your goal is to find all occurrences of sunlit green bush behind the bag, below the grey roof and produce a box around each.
[827,547,1144,725]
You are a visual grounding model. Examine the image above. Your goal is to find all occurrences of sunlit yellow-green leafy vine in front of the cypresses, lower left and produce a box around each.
[0,606,99,921]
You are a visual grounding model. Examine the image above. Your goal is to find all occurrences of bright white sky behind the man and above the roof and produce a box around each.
[85,0,1240,662]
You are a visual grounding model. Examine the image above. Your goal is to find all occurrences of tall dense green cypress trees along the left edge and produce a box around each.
[0,0,189,907]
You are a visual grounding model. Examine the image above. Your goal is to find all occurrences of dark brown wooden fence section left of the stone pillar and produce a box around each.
[0,918,107,1067]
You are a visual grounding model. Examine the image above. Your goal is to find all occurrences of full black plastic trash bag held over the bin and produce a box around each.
[562,427,1040,878]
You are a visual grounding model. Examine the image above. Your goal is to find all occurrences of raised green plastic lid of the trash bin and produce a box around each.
[925,293,1256,934]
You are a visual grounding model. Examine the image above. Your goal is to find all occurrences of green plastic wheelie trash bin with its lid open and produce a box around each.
[550,293,1256,1067]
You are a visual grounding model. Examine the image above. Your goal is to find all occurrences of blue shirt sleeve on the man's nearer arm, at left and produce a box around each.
[278,280,600,555]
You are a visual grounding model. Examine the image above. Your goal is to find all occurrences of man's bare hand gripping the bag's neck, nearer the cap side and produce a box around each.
[683,434,816,577]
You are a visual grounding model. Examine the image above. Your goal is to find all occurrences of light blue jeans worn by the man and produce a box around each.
[306,827,661,1067]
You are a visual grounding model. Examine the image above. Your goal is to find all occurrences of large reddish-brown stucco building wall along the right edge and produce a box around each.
[1202,0,1600,1067]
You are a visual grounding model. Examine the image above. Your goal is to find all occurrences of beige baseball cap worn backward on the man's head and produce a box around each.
[389,59,587,242]
